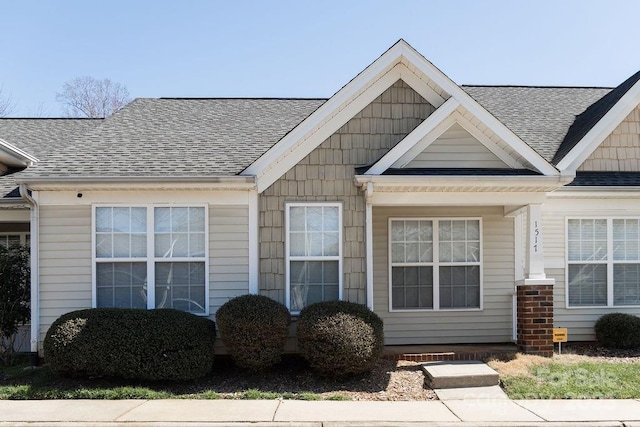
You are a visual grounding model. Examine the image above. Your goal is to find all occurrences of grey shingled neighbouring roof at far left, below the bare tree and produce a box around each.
[0,118,102,197]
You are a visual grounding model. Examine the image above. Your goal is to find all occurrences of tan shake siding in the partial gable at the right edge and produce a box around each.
[578,107,640,172]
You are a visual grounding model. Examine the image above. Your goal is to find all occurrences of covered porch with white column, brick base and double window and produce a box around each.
[356,174,564,360]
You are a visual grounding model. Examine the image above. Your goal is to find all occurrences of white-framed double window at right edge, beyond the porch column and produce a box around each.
[567,218,640,307]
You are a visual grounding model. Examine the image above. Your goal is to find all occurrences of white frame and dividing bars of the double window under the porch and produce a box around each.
[387,217,484,313]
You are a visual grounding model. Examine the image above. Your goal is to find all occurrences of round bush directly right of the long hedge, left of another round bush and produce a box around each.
[216,295,291,371]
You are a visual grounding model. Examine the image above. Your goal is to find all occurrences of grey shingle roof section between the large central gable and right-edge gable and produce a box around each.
[462,85,612,164]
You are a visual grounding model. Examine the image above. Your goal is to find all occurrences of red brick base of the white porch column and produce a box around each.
[516,282,553,357]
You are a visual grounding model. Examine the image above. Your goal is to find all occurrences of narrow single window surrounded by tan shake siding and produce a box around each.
[285,203,342,312]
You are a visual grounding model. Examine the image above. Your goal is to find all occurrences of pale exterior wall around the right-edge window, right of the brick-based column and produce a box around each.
[542,197,640,341]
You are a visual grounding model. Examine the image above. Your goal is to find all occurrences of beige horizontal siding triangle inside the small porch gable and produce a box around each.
[405,124,508,168]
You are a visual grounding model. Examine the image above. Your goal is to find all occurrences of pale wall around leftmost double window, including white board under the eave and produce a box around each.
[38,191,249,349]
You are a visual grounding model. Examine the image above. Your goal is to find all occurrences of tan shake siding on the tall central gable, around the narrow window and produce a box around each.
[259,80,434,304]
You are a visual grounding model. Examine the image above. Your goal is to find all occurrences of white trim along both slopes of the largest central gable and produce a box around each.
[241,40,558,192]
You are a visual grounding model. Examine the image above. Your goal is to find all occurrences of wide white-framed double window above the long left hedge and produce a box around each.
[94,206,208,314]
